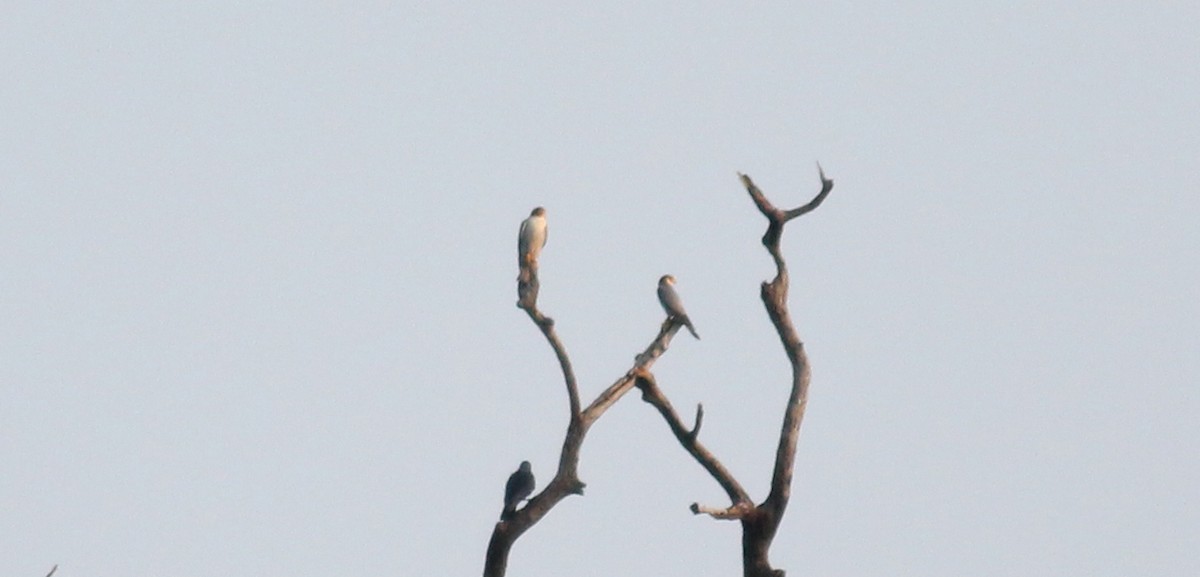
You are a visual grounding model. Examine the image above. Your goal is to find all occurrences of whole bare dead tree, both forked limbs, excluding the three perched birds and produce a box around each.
[484,166,833,577]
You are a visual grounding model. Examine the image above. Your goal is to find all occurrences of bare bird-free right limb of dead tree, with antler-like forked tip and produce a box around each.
[637,166,833,577]
